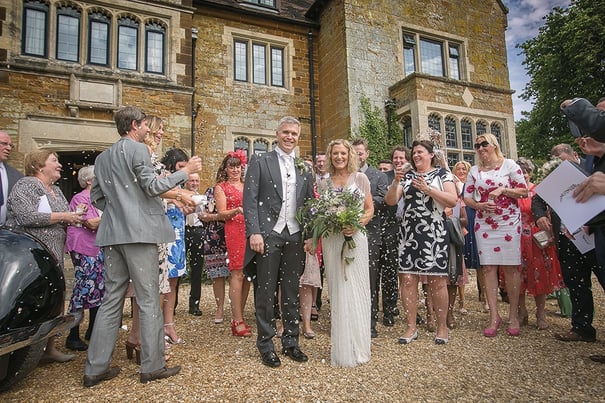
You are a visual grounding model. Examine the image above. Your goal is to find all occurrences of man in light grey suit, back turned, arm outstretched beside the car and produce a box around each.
[84,106,201,387]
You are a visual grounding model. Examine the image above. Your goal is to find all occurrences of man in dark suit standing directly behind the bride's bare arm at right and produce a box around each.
[352,138,388,338]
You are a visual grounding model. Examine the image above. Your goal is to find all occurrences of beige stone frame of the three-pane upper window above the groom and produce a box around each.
[223,26,295,92]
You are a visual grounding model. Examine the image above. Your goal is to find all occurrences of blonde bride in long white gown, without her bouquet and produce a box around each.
[319,139,374,367]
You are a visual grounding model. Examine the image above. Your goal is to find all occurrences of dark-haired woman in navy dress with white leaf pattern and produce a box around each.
[384,140,458,345]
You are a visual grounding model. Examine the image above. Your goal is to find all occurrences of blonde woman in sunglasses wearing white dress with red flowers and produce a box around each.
[464,133,527,337]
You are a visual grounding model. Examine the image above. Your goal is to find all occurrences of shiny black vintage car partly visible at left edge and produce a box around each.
[0,228,74,392]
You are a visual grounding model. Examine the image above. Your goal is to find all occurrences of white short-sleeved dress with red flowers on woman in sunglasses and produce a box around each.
[464,159,527,266]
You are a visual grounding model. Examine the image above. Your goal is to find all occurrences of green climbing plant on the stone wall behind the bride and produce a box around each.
[352,95,403,167]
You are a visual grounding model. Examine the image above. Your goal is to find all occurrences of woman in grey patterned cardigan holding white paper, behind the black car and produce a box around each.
[6,150,82,362]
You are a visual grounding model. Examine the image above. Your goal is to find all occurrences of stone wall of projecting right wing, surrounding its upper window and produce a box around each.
[319,0,514,147]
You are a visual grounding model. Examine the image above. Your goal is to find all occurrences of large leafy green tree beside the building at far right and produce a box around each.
[516,0,605,159]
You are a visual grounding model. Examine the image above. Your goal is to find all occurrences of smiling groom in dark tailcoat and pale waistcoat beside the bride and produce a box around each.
[244,116,314,367]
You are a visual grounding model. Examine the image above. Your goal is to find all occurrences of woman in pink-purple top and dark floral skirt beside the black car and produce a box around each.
[65,165,105,351]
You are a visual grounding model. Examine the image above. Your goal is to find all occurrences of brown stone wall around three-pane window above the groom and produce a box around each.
[193,8,321,189]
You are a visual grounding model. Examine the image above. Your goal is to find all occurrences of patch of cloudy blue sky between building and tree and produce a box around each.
[502,0,570,121]
